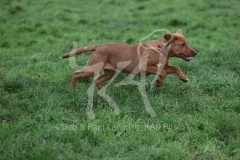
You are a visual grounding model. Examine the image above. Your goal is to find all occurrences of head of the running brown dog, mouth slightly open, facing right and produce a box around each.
[164,29,197,61]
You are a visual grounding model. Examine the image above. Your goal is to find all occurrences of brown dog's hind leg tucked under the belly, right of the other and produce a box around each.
[94,69,115,89]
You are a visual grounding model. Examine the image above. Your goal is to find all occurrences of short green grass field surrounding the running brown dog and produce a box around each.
[0,0,240,160]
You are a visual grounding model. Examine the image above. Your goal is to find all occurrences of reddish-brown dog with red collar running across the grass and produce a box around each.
[62,29,197,88]
